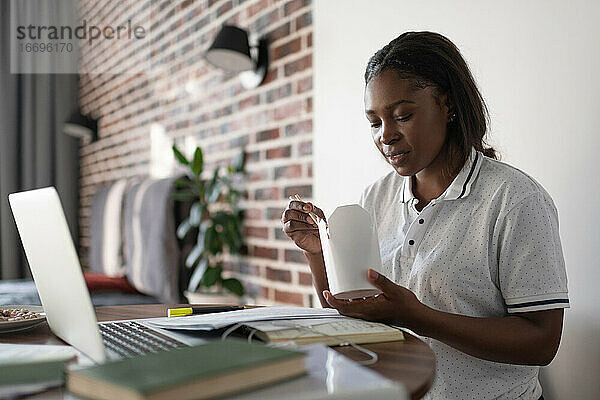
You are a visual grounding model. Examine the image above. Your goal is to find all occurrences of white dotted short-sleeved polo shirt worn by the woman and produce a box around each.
[360,149,569,400]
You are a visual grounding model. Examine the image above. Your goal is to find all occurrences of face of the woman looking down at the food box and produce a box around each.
[365,70,448,176]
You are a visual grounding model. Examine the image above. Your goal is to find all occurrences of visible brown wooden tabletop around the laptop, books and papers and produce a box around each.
[0,304,435,399]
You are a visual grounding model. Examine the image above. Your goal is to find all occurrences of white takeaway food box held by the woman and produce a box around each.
[319,204,381,299]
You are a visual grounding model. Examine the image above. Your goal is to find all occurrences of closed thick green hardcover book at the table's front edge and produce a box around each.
[67,340,306,400]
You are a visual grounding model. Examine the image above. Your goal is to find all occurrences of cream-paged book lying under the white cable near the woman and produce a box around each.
[245,317,404,346]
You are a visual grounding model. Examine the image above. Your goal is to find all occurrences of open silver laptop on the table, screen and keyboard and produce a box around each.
[8,187,205,363]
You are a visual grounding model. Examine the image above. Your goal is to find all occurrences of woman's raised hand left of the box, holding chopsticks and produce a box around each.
[281,200,325,254]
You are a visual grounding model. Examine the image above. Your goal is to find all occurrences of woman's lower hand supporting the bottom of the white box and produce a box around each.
[323,269,424,328]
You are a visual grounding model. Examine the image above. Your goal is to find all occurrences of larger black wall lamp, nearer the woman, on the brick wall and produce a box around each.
[205,25,269,89]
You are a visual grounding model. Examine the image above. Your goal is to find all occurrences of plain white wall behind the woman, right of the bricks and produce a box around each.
[313,0,600,400]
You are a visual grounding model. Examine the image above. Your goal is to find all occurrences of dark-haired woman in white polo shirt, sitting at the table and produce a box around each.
[282,32,569,400]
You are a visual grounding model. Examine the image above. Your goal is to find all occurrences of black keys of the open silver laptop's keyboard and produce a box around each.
[98,321,187,358]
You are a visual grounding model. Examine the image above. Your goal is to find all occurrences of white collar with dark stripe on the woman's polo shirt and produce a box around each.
[401,148,483,203]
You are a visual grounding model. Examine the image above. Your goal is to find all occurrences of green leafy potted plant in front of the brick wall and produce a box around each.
[173,146,245,303]
